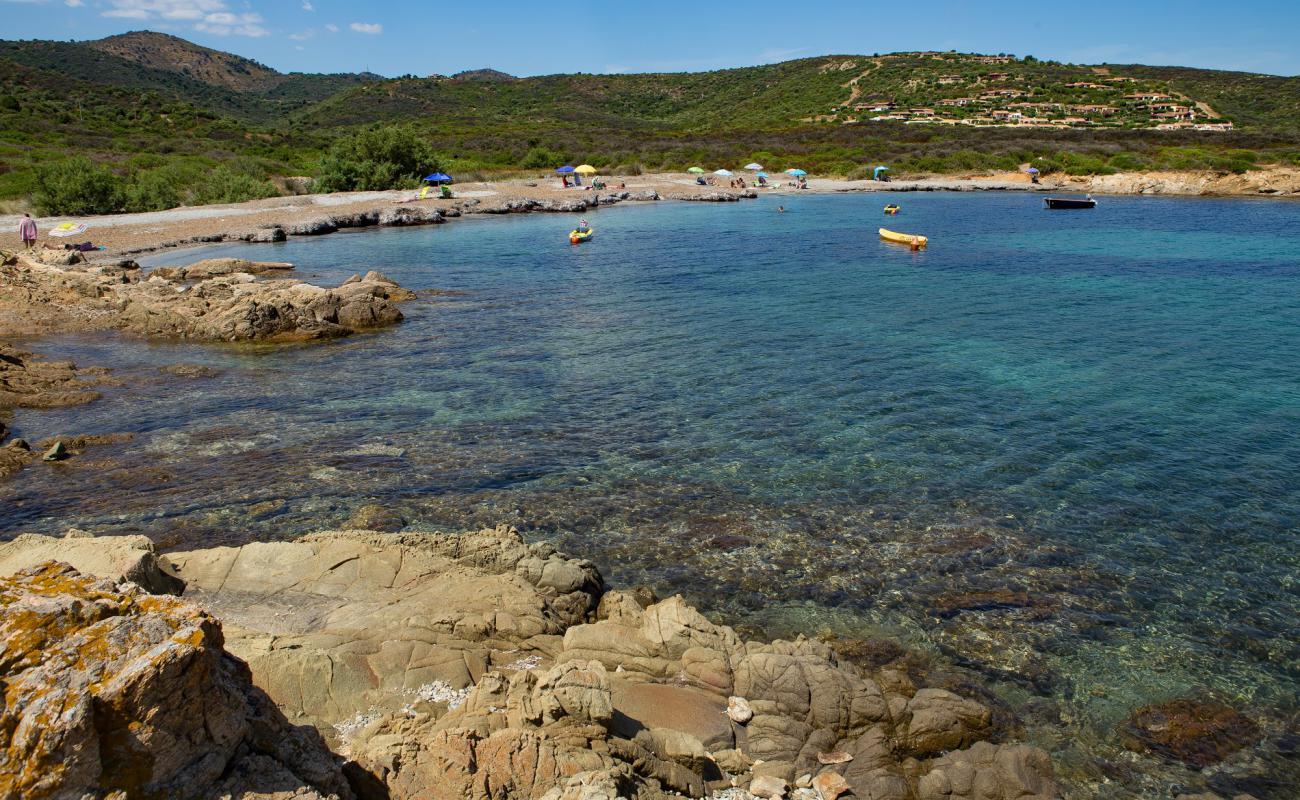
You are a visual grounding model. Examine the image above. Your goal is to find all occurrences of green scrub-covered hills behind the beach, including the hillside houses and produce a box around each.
[0,33,1300,211]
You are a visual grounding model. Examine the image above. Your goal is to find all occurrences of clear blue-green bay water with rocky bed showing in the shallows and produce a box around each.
[0,194,1300,797]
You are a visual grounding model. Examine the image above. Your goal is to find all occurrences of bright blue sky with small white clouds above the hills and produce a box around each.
[0,0,1300,75]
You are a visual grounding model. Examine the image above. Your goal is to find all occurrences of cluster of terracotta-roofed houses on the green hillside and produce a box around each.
[818,52,1232,131]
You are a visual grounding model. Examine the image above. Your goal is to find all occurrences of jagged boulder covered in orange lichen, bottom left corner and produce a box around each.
[0,562,352,800]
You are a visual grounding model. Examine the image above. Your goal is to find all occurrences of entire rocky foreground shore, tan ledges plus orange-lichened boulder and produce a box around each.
[0,528,1057,800]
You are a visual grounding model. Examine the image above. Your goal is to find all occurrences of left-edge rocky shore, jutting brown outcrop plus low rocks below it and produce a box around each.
[0,250,415,480]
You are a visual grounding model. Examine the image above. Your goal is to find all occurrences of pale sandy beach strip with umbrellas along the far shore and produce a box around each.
[0,168,1300,261]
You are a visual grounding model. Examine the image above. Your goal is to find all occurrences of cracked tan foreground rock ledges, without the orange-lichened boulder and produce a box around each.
[154,528,1056,800]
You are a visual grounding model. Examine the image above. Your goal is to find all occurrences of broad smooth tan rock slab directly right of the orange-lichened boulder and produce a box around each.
[165,529,601,732]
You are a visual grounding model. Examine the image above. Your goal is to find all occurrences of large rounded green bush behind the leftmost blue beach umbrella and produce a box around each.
[315,125,442,191]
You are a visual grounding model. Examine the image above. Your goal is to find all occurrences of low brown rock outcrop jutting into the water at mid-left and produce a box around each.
[0,259,413,342]
